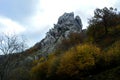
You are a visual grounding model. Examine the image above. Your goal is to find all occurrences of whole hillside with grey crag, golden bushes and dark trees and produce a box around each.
[0,7,120,80]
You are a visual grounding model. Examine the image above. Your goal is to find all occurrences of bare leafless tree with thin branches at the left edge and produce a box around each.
[0,34,26,80]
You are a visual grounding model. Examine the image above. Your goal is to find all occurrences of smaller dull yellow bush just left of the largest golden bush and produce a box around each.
[30,54,59,80]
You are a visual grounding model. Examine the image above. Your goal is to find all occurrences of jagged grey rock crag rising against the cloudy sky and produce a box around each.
[35,12,82,54]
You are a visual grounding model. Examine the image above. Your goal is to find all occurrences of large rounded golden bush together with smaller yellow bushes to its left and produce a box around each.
[31,44,101,80]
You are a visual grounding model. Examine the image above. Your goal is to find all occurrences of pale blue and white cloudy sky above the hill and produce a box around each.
[0,0,120,46]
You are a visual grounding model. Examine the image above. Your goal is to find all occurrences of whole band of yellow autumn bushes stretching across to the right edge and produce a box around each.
[31,41,120,80]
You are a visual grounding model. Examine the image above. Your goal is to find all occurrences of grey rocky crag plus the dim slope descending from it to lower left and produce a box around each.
[0,12,82,80]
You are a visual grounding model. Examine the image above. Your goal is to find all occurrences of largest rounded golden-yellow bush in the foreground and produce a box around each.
[57,44,101,77]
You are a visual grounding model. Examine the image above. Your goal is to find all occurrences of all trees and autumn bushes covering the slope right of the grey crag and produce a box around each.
[30,7,120,80]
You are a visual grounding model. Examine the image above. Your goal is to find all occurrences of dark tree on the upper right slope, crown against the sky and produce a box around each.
[88,7,120,42]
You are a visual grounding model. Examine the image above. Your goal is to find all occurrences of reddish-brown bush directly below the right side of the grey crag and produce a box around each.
[58,32,86,51]
